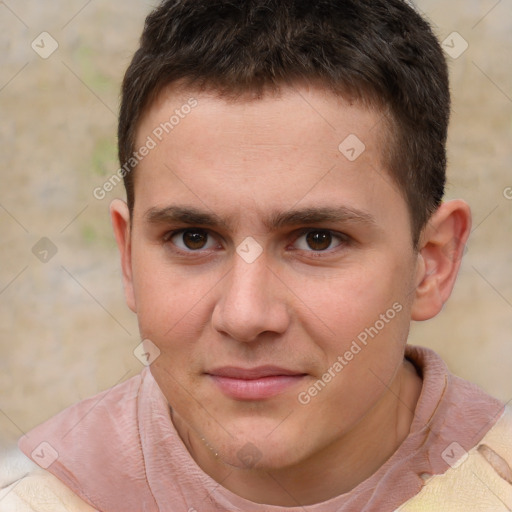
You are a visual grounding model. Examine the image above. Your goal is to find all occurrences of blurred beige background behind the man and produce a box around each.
[0,0,512,448]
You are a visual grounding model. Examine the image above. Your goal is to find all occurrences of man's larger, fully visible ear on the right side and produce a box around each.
[411,199,471,320]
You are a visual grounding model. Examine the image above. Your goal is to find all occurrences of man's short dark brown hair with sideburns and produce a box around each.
[118,0,450,245]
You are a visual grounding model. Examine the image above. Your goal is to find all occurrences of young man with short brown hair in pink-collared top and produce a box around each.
[0,0,512,512]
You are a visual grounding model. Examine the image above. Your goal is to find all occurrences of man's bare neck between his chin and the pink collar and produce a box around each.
[176,361,422,507]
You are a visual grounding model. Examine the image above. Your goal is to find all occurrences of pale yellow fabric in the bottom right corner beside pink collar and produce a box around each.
[398,406,512,512]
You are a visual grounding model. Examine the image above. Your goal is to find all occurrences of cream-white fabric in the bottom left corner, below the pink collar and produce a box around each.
[0,446,96,512]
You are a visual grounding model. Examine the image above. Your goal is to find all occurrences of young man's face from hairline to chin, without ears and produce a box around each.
[119,84,417,468]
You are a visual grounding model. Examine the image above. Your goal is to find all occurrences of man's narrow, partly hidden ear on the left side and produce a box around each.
[110,199,136,313]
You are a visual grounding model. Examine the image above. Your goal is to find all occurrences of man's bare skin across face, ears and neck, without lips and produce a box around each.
[111,86,470,506]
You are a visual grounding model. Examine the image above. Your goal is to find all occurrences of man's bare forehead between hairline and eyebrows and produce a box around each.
[134,87,403,229]
